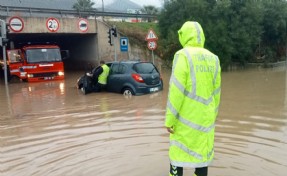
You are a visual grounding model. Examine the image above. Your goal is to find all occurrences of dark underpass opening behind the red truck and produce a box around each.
[1,33,97,71]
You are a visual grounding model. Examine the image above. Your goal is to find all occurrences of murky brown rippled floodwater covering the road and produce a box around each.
[0,68,287,176]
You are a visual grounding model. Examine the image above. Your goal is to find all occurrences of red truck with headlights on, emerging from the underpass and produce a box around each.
[1,44,69,82]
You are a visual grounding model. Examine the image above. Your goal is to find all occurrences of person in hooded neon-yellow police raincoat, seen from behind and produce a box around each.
[165,21,221,176]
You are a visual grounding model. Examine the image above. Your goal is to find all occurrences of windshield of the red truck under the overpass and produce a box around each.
[26,48,61,63]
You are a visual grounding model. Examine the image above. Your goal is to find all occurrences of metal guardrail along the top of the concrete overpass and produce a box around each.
[0,5,157,18]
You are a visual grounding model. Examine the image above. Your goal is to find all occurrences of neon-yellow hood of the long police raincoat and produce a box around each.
[178,21,205,48]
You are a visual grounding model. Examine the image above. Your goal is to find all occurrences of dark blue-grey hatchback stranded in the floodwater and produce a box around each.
[77,61,163,95]
